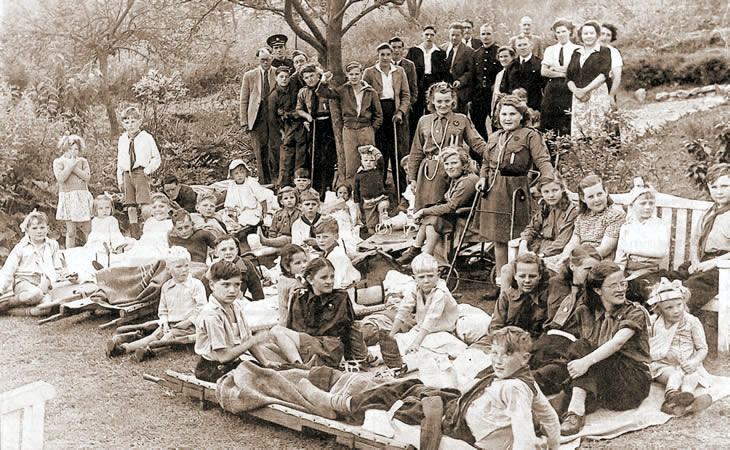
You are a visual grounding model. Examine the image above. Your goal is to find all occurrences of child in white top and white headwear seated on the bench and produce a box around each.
[616,182,672,305]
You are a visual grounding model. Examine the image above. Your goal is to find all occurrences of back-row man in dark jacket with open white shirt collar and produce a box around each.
[406,25,448,119]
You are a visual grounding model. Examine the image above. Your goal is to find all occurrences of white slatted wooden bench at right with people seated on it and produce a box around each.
[509,193,730,355]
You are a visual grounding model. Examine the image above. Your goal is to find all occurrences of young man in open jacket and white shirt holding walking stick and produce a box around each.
[363,43,411,192]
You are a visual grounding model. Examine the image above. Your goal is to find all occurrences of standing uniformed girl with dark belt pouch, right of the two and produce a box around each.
[474,95,555,284]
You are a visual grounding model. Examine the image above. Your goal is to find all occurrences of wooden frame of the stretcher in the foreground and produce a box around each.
[143,370,414,449]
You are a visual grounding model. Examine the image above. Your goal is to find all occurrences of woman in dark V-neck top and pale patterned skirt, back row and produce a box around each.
[567,21,611,138]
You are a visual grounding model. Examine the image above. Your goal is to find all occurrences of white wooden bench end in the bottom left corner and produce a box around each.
[0,381,56,450]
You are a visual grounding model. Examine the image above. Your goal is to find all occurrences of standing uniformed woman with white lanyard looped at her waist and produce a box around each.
[408,82,487,211]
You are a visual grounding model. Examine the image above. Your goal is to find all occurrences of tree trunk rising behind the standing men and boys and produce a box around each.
[325,0,345,186]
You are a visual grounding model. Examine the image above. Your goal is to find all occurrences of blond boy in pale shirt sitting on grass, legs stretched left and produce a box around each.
[107,246,207,362]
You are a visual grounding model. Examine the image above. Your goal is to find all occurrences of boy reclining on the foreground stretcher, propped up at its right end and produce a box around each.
[298,326,560,450]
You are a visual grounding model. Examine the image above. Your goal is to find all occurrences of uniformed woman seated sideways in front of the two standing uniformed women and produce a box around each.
[398,148,479,264]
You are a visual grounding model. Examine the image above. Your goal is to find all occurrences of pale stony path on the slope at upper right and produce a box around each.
[631,95,727,136]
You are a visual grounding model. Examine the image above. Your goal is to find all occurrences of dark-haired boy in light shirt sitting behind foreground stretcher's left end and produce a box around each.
[195,261,275,383]
